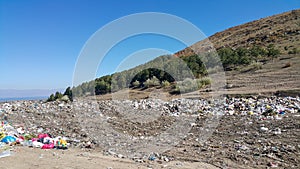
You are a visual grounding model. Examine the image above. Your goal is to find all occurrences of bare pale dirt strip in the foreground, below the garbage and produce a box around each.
[0,147,216,169]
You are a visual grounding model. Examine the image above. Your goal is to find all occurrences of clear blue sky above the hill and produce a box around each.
[0,0,300,89]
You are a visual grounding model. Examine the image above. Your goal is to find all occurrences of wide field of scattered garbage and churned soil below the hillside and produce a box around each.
[0,96,300,168]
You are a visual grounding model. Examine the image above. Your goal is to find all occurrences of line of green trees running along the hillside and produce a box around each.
[48,45,280,101]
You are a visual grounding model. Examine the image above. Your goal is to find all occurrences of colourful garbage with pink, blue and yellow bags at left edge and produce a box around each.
[0,101,70,157]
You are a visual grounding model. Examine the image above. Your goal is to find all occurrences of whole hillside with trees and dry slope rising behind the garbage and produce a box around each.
[63,10,300,98]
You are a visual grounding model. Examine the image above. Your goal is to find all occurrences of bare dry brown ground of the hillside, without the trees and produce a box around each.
[155,10,300,98]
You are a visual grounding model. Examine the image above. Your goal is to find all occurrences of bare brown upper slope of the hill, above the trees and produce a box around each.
[175,9,300,56]
